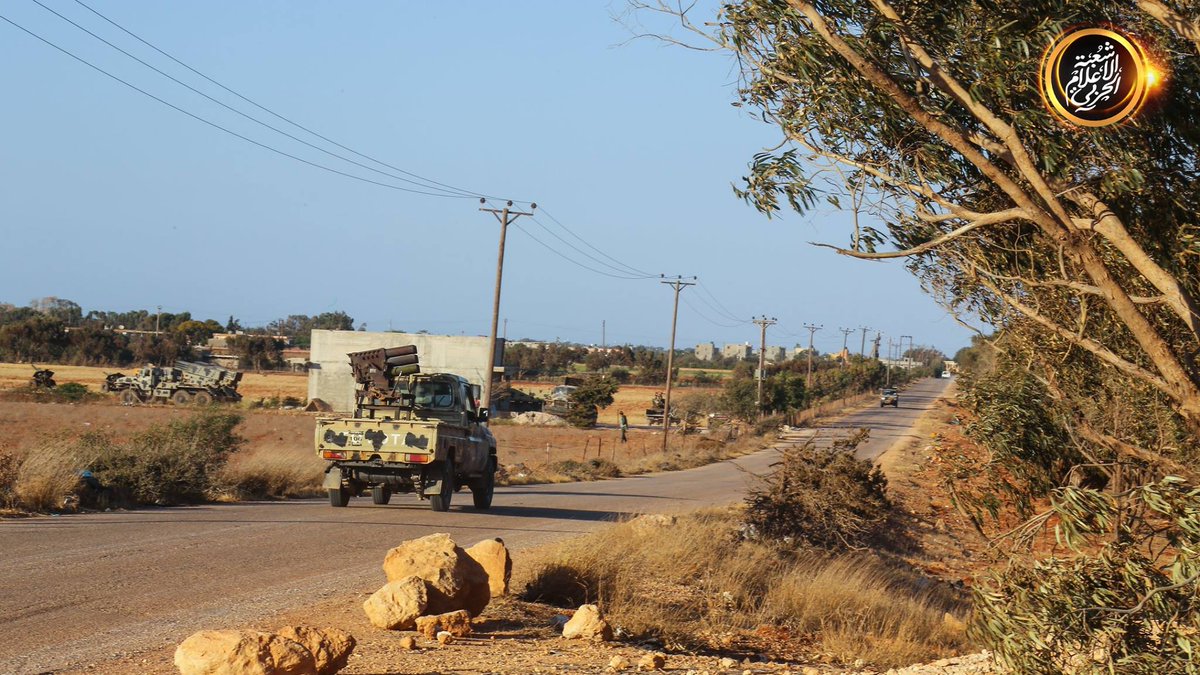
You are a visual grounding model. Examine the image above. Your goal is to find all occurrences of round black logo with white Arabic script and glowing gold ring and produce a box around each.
[1042,28,1156,126]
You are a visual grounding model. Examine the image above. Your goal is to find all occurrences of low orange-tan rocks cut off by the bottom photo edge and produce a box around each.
[175,626,355,675]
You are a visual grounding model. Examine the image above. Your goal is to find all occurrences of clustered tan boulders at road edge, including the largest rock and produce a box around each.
[362,533,512,639]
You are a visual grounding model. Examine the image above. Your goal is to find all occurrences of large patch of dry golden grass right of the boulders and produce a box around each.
[524,510,966,667]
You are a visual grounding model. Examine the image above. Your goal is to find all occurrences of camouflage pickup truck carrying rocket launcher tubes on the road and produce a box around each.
[316,345,497,510]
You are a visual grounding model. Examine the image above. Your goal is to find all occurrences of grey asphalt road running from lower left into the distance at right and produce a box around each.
[0,380,946,674]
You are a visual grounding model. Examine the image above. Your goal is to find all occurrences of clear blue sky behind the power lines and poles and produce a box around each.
[0,0,968,353]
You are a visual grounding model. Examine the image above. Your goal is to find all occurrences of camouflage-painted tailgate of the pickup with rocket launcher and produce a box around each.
[316,418,438,464]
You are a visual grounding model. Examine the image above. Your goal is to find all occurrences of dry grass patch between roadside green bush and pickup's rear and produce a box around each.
[217,450,325,500]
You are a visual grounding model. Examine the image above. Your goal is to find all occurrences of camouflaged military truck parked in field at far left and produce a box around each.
[100,360,241,406]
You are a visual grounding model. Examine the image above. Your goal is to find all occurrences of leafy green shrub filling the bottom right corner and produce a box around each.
[971,477,1200,675]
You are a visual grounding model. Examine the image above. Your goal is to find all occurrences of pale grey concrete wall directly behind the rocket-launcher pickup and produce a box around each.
[308,330,504,412]
